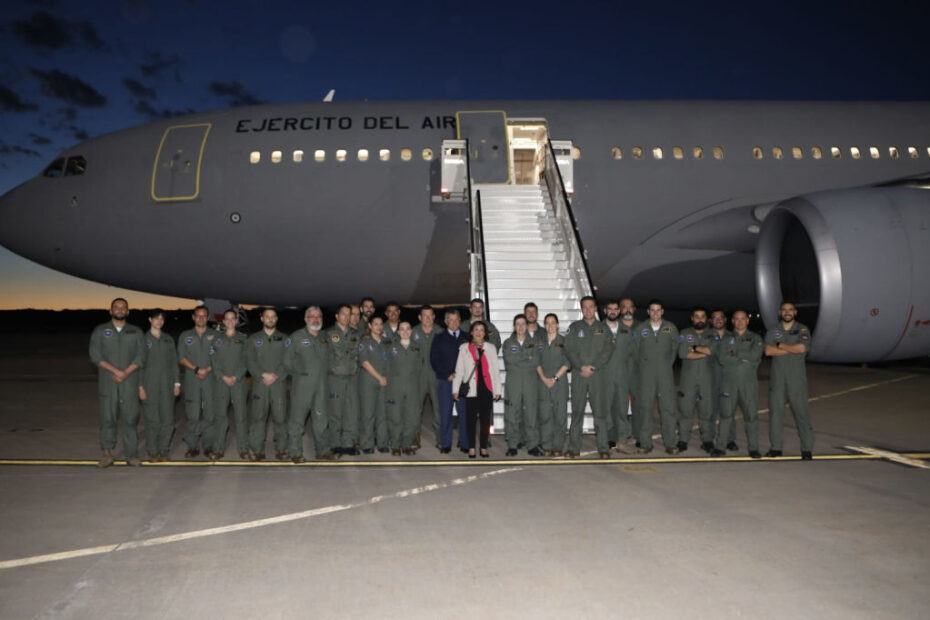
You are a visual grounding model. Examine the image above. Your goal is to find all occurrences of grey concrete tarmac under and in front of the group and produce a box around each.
[0,330,930,619]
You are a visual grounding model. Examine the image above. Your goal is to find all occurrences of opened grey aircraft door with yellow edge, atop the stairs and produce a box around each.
[455,110,510,184]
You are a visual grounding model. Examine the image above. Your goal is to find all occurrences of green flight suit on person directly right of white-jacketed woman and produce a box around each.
[501,335,540,450]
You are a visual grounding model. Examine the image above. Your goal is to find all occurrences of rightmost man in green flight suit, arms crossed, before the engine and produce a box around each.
[765,301,814,461]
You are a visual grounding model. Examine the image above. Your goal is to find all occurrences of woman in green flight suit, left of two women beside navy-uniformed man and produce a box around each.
[358,316,391,454]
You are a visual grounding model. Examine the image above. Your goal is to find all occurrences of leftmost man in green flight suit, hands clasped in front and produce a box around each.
[89,297,145,467]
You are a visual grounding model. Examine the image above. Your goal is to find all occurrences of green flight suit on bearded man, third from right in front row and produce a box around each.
[678,327,716,444]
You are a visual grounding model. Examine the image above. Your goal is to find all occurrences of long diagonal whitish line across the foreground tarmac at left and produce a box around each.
[0,467,523,569]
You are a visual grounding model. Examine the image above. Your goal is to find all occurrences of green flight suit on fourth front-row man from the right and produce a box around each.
[632,320,678,448]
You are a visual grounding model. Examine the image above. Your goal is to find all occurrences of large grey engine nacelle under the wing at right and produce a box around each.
[756,188,930,362]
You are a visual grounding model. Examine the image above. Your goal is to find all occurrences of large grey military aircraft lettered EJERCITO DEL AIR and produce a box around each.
[0,101,930,362]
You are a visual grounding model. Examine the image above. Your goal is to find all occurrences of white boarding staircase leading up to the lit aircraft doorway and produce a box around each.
[450,142,594,433]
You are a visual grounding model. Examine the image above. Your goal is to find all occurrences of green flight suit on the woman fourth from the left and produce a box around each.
[204,332,248,454]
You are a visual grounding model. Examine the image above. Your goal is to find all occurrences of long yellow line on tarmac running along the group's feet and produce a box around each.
[0,446,930,469]
